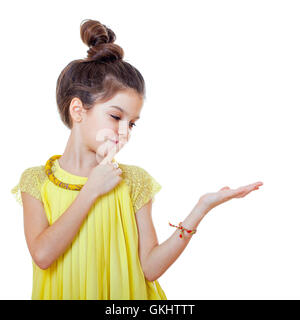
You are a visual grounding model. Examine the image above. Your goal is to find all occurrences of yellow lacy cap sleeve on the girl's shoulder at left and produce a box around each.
[11,165,47,206]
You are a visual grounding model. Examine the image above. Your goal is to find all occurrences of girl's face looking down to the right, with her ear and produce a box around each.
[71,89,143,158]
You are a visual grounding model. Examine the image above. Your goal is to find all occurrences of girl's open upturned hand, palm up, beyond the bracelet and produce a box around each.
[197,181,263,213]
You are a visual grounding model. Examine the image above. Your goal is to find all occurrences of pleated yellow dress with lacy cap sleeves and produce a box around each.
[11,159,167,300]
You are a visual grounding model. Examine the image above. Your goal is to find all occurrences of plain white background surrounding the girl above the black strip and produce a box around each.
[0,0,300,299]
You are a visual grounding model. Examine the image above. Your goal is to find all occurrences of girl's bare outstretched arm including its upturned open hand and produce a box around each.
[135,181,263,281]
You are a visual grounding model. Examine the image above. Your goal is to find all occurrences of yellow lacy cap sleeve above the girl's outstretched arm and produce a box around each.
[119,163,162,212]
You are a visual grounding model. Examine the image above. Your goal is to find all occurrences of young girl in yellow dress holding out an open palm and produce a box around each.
[11,20,262,300]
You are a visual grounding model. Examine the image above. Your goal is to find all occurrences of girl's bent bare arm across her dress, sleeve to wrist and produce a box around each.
[21,187,96,269]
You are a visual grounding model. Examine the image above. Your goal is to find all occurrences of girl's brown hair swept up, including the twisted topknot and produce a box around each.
[56,19,146,129]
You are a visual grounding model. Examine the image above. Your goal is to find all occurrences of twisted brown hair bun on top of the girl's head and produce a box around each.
[80,19,124,62]
